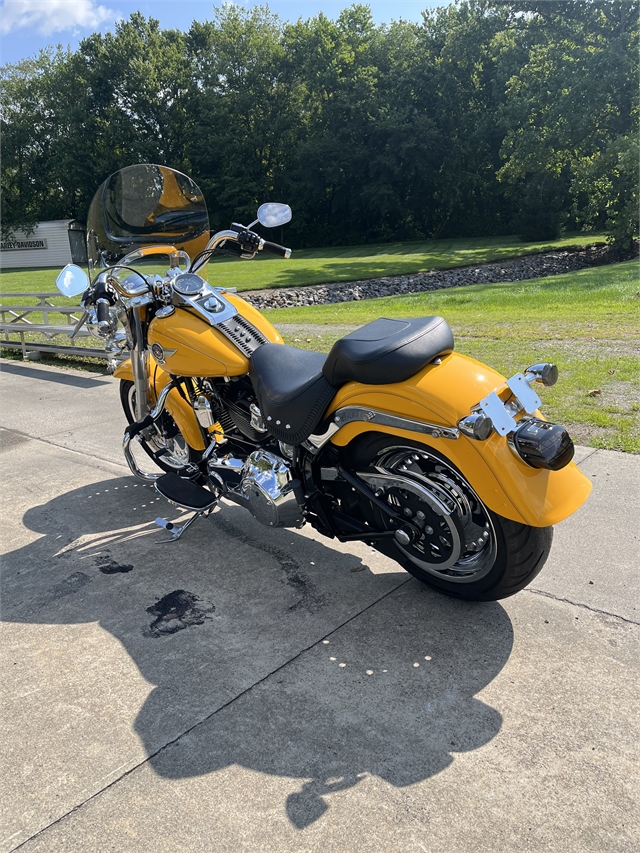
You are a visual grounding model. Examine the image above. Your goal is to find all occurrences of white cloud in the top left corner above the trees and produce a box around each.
[0,0,120,36]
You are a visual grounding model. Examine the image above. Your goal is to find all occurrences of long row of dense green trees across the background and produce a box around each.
[0,0,640,245]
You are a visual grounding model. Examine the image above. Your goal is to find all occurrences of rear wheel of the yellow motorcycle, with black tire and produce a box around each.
[345,434,553,601]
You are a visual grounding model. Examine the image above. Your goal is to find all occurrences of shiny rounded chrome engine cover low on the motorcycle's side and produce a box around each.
[240,450,304,527]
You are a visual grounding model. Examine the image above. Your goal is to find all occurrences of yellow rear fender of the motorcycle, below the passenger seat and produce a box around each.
[327,353,591,527]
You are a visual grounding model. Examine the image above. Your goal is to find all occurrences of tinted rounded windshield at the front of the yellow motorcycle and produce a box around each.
[87,163,209,273]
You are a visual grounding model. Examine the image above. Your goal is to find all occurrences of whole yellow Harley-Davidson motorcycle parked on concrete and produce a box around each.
[57,164,591,601]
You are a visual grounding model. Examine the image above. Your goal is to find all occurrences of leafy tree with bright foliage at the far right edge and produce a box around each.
[498,0,639,239]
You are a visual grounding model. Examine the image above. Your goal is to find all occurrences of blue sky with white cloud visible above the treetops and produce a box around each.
[0,0,452,64]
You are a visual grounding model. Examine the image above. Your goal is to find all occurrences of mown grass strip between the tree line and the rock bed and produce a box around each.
[0,233,604,301]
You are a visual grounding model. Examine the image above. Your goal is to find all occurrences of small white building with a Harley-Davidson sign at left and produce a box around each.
[0,219,87,270]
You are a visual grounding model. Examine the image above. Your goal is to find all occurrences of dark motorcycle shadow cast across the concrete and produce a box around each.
[3,478,513,829]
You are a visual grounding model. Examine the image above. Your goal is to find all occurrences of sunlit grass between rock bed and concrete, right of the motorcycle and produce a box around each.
[264,261,640,453]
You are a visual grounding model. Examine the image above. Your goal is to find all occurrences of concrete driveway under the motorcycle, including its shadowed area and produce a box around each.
[0,361,640,853]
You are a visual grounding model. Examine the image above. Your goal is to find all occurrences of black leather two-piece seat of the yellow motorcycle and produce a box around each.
[250,317,453,444]
